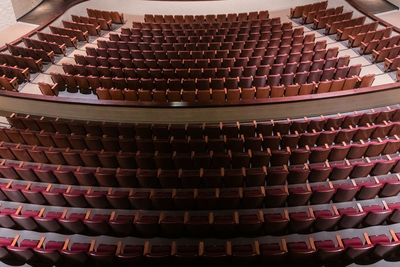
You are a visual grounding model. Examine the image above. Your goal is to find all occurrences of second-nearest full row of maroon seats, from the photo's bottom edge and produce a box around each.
[0,196,400,237]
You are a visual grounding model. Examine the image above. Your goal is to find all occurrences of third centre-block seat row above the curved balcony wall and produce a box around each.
[62,55,346,79]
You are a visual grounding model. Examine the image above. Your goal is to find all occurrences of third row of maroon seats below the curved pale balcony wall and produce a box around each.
[0,133,400,169]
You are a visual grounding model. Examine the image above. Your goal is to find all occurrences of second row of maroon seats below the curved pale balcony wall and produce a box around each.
[0,112,400,152]
